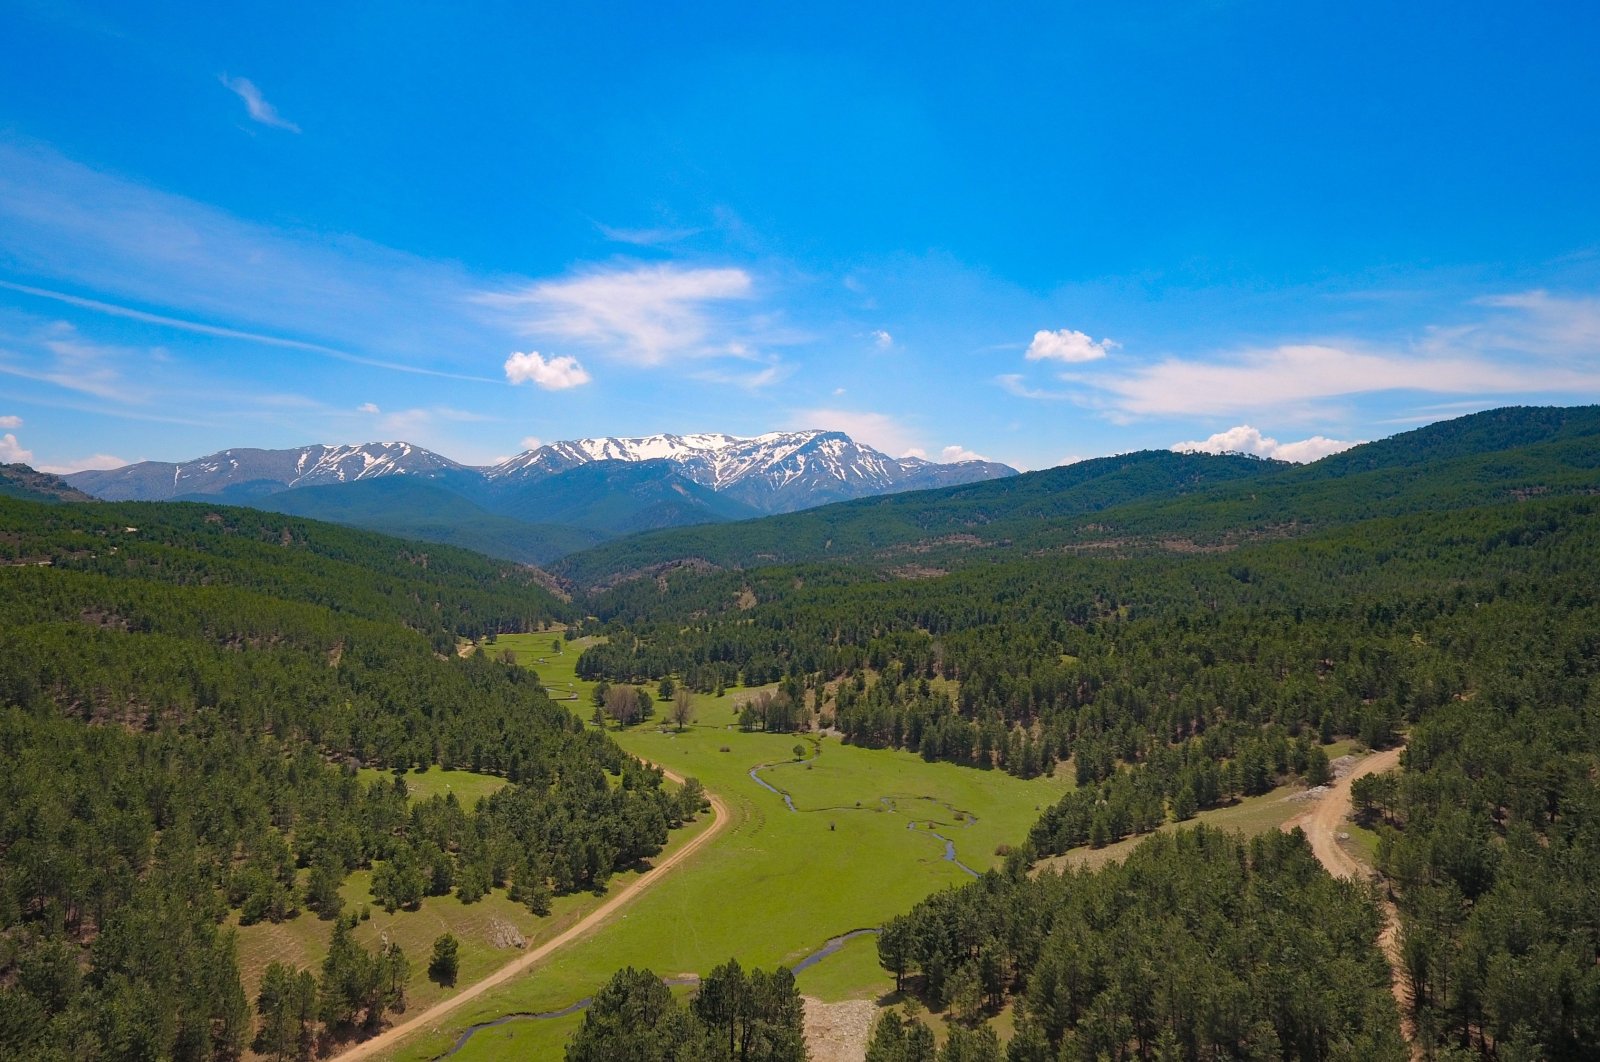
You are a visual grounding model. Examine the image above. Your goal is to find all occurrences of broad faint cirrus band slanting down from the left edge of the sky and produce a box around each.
[0,133,509,375]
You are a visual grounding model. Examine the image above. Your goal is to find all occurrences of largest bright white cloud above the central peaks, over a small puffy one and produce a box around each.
[477,266,752,365]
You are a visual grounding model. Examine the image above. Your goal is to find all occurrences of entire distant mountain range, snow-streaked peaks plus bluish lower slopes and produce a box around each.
[64,430,1016,565]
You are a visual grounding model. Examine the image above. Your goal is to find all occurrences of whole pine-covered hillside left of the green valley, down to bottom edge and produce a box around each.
[0,499,713,1062]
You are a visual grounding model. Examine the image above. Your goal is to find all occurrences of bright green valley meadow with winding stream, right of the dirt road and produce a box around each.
[380,635,1070,1062]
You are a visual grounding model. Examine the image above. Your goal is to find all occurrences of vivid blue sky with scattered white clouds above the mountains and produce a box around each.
[0,0,1600,470]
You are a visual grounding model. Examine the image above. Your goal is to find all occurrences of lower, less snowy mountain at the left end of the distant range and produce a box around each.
[66,443,478,501]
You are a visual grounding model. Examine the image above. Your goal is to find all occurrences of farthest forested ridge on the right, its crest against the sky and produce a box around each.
[554,406,1600,587]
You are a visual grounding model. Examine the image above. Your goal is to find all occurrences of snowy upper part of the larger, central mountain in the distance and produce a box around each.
[485,430,1016,513]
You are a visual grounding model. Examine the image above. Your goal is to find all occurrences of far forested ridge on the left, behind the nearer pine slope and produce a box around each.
[0,497,571,653]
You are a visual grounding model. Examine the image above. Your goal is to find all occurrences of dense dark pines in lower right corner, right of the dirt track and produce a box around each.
[1352,610,1600,1059]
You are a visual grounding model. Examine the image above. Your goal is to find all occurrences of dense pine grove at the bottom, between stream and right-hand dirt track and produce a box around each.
[878,827,1405,1060]
